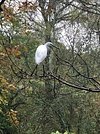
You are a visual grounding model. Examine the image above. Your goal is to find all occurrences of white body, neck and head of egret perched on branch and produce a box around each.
[35,42,54,65]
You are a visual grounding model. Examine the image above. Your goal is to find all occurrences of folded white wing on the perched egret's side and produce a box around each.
[35,45,47,64]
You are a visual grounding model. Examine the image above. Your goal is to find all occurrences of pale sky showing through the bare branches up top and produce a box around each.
[0,0,98,47]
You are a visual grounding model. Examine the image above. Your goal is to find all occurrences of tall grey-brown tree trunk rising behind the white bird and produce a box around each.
[39,0,54,134]
